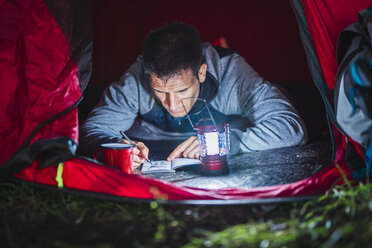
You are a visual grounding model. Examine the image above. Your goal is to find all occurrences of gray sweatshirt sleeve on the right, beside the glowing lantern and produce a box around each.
[212,55,307,154]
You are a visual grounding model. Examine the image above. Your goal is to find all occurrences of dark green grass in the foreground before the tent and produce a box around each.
[0,170,372,248]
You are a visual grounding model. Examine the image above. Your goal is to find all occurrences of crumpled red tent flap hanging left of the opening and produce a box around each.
[0,0,81,169]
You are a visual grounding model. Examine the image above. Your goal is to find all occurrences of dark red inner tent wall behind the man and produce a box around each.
[79,0,328,142]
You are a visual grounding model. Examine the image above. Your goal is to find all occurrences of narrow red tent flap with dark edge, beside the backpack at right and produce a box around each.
[291,0,372,169]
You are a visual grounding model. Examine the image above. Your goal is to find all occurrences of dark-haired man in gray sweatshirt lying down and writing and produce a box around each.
[80,23,307,170]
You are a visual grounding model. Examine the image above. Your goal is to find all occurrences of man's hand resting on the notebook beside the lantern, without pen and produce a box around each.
[167,136,200,161]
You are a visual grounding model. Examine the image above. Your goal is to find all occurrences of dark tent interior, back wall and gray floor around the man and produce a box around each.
[79,1,332,188]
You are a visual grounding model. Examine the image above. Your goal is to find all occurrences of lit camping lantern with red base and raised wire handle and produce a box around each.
[182,98,230,175]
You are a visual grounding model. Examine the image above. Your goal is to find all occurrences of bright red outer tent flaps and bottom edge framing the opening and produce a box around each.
[0,0,371,204]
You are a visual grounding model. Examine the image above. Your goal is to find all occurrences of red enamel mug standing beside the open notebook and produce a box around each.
[93,143,134,174]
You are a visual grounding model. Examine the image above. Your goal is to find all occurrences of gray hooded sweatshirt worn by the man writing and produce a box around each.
[80,43,307,155]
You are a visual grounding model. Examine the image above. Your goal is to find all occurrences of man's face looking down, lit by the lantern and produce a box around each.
[150,69,204,117]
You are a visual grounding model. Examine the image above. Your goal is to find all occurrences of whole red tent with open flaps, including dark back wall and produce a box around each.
[0,0,371,204]
